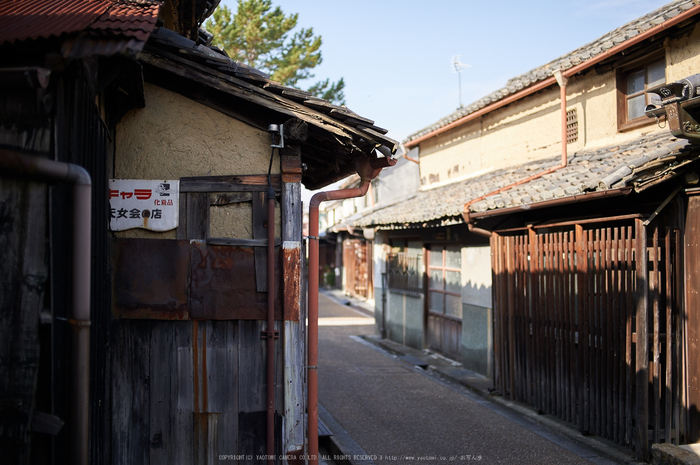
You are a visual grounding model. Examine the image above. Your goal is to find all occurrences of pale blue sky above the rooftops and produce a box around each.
[222,0,668,141]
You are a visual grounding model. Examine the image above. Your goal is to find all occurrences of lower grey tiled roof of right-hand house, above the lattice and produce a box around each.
[352,130,700,227]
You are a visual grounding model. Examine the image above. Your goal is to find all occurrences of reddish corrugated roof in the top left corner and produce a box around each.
[0,0,161,57]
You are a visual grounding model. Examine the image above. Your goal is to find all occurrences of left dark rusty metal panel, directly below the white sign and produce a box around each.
[112,239,190,320]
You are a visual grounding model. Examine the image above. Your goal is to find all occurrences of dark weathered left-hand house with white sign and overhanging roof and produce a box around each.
[0,0,396,464]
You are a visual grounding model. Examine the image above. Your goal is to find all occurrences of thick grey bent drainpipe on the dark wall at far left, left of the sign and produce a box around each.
[0,150,92,465]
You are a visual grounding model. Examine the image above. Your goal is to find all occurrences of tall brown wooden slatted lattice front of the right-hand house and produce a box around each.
[491,217,686,458]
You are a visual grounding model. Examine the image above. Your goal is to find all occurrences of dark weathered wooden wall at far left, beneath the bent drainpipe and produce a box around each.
[0,177,48,464]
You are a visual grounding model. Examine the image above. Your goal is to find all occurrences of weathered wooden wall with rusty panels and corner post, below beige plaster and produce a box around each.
[112,167,305,465]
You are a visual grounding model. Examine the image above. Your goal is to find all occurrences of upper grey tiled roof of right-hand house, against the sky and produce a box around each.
[404,0,696,142]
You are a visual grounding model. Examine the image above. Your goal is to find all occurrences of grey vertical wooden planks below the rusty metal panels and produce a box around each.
[112,320,284,465]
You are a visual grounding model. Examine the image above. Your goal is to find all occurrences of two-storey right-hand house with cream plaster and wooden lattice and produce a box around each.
[353,1,700,458]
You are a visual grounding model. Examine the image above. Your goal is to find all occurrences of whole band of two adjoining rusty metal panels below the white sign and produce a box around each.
[112,239,284,320]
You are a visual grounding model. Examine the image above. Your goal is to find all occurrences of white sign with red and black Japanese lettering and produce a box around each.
[109,179,180,231]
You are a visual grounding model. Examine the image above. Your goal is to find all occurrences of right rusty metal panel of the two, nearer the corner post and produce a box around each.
[190,242,282,320]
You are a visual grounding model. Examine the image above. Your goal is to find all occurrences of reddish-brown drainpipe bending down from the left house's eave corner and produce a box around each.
[307,153,396,465]
